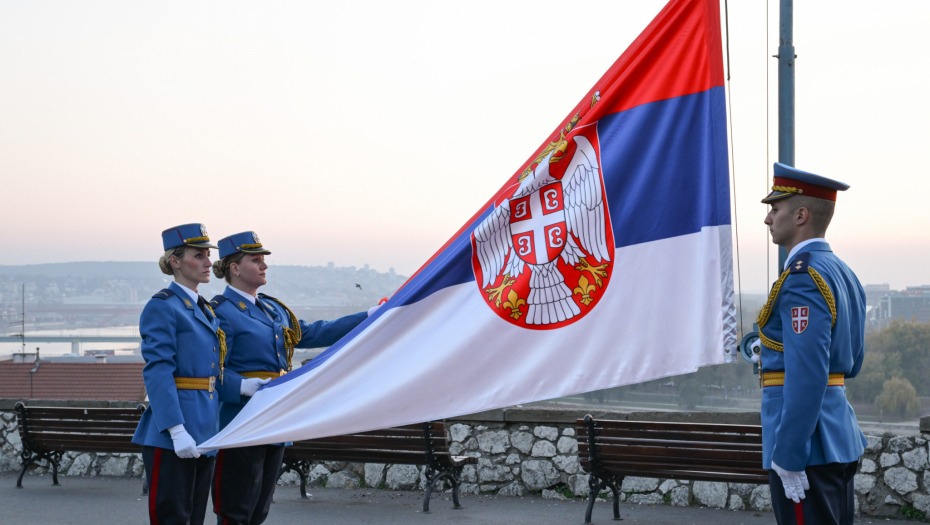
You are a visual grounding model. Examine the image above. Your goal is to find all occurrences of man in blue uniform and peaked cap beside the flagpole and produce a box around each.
[758,163,867,525]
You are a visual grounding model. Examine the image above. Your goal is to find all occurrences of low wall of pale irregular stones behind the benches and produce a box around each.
[0,400,930,517]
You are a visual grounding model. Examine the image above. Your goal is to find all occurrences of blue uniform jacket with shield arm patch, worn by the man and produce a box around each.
[759,242,867,471]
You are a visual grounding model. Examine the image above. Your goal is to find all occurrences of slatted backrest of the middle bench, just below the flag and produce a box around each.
[285,421,449,465]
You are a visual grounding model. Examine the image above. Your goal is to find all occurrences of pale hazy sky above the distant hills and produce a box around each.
[0,0,930,292]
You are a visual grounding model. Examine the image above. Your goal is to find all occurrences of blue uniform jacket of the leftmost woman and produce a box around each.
[132,283,220,456]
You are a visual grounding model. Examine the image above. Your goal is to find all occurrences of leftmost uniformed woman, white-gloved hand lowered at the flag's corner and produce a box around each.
[132,224,225,525]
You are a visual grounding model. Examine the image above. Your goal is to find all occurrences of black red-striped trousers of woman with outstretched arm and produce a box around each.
[213,445,284,525]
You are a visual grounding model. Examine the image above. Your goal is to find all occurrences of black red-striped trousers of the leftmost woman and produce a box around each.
[142,447,215,525]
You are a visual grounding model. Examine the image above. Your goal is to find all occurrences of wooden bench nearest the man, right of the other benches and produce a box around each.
[577,415,769,523]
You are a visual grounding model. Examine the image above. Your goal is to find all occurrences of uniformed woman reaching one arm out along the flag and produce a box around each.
[211,232,373,525]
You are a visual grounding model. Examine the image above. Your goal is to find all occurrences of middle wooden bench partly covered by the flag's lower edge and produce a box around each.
[281,421,478,514]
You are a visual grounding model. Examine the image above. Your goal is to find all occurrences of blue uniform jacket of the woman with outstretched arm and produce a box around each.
[210,286,368,428]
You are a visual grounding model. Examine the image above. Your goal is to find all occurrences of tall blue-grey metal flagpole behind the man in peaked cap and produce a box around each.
[775,0,797,273]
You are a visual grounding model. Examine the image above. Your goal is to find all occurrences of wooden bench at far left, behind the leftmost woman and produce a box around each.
[13,403,145,489]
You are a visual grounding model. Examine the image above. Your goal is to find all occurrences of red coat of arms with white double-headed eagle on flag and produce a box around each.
[472,122,614,329]
